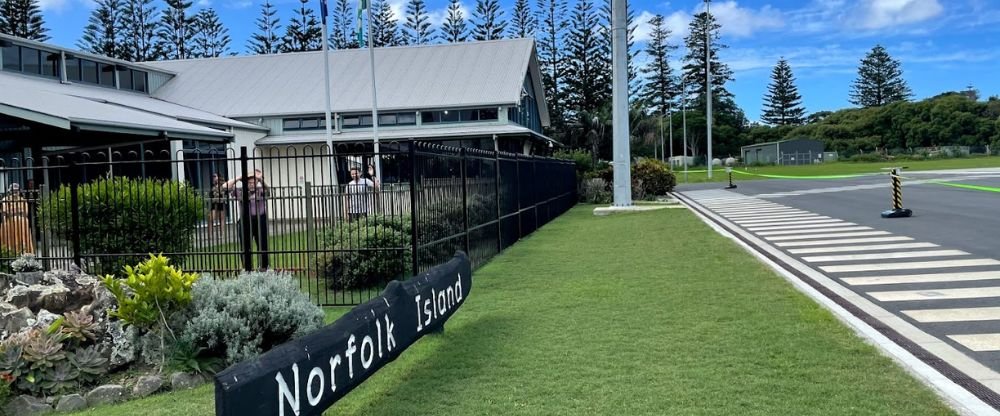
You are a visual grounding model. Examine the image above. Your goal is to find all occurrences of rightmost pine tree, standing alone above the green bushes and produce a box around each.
[851,45,913,107]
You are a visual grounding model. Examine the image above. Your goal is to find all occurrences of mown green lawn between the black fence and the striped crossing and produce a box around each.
[68,206,953,416]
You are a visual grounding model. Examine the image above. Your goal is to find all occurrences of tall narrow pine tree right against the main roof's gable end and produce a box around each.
[536,0,569,133]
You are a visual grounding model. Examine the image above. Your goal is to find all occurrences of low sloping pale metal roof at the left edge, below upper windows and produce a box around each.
[0,75,233,139]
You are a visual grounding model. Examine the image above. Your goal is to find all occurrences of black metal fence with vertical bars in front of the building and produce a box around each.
[0,141,576,305]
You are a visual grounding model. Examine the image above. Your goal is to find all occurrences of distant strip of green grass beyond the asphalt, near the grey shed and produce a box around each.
[674,156,1000,183]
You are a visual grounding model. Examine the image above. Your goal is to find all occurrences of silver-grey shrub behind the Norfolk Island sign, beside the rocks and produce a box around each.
[181,272,323,364]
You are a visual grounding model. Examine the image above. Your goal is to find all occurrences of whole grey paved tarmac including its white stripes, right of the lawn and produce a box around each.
[678,169,1000,412]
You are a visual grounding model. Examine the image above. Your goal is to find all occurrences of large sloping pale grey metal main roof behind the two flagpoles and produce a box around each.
[146,39,548,125]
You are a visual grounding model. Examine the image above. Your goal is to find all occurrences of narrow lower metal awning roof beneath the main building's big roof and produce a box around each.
[256,124,554,146]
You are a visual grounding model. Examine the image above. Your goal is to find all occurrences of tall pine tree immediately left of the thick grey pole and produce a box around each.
[566,0,611,114]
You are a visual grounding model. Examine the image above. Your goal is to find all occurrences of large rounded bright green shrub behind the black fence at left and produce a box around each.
[39,177,204,275]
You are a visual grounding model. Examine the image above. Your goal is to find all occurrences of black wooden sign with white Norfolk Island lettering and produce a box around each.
[215,252,472,416]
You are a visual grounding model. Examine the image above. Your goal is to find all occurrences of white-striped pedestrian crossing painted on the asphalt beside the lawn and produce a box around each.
[684,190,1000,360]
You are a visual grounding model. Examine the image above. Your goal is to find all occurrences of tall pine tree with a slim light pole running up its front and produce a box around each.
[684,12,733,107]
